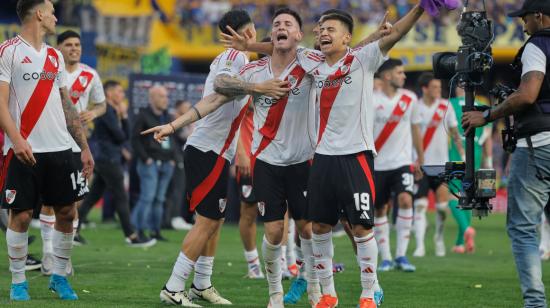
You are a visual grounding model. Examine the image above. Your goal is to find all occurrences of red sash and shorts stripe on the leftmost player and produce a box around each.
[0,48,59,189]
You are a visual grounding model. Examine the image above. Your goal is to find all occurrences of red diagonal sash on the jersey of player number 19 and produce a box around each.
[317,54,355,144]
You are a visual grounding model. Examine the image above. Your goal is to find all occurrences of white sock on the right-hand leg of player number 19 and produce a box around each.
[354,233,378,298]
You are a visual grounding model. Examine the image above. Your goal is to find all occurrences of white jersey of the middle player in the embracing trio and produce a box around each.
[241,57,317,166]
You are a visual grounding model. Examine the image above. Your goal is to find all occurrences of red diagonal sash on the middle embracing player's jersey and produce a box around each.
[250,65,306,170]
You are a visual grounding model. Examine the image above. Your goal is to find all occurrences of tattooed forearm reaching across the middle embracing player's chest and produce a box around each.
[214,74,290,99]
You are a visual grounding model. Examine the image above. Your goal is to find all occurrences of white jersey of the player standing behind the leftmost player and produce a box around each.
[67,63,105,152]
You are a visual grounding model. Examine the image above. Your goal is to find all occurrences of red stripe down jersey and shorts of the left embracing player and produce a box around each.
[189,104,248,211]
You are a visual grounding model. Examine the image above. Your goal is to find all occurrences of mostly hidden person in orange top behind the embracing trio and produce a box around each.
[235,102,265,279]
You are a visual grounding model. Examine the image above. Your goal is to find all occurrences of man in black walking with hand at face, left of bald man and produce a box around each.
[78,80,156,247]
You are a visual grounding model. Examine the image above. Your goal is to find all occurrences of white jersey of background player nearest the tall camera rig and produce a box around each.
[413,99,458,165]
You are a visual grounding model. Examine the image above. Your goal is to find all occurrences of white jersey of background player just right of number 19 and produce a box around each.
[373,89,420,171]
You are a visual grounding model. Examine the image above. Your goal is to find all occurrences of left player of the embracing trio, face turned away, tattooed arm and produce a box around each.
[144,10,288,307]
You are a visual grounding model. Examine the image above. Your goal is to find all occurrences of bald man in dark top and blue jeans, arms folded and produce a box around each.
[131,86,176,241]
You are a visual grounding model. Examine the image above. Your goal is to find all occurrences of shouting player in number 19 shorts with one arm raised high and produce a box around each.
[221,6,424,307]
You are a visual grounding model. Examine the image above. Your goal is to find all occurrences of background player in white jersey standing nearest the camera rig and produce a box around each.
[413,73,464,257]
